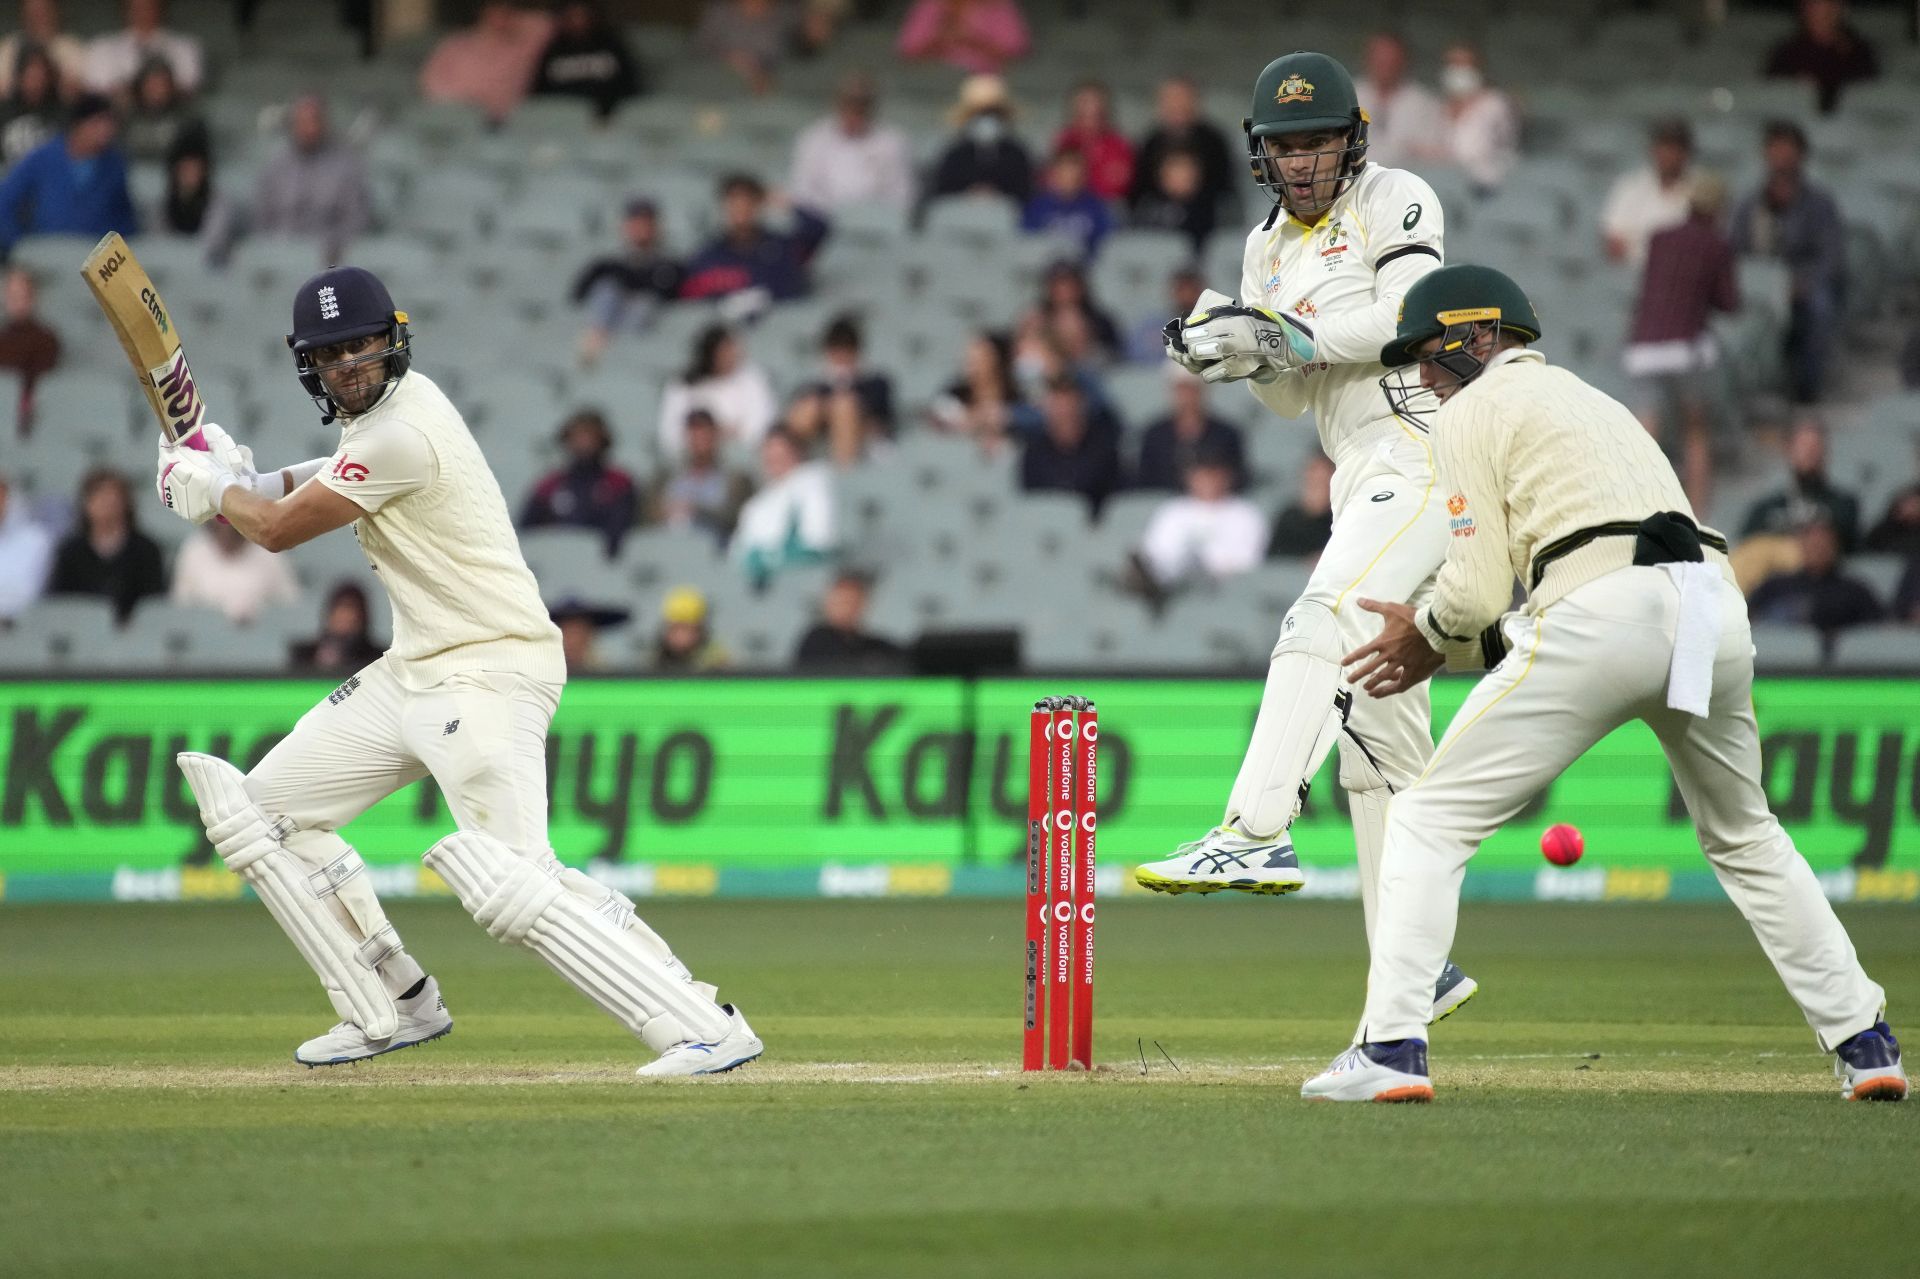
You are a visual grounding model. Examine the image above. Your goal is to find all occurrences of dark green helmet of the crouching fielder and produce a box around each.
[1380,265,1540,424]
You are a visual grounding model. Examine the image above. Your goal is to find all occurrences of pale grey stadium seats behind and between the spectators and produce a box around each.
[0,0,1920,670]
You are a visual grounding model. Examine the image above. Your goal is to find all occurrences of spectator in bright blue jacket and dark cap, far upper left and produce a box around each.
[0,94,140,257]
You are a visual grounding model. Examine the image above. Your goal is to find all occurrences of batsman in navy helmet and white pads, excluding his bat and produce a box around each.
[159,267,760,1075]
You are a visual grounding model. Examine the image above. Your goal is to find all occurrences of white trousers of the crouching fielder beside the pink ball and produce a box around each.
[1356,568,1885,1050]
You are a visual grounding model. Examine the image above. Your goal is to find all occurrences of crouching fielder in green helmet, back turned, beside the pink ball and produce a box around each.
[1302,267,1907,1100]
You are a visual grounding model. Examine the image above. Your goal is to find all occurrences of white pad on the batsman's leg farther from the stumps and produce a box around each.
[175,751,399,1039]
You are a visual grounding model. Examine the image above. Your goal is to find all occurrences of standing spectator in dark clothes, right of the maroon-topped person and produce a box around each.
[1734,121,1847,403]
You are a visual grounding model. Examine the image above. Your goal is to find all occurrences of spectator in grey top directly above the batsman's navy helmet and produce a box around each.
[253,94,372,261]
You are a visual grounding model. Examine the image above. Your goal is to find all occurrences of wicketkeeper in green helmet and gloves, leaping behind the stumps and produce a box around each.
[1135,52,1476,1018]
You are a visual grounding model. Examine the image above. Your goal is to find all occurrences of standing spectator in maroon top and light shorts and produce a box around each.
[1624,175,1740,511]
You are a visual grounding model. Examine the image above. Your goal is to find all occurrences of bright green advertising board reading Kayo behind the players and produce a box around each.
[0,678,1920,901]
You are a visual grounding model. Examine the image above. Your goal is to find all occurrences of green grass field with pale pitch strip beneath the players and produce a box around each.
[0,899,1920,1279]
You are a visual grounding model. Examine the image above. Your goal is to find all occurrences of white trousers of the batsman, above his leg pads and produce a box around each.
[246,657,561,853]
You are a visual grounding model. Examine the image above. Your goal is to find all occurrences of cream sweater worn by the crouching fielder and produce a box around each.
[1417,348,1734,670]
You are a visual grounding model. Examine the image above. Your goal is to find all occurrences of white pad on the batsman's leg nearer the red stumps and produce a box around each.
[426,830,728,1052]
